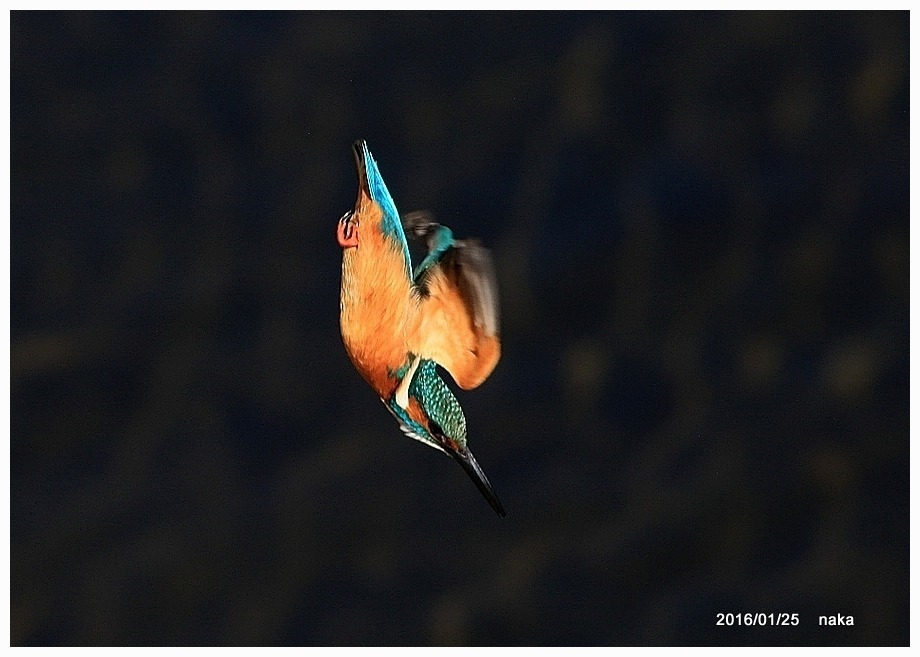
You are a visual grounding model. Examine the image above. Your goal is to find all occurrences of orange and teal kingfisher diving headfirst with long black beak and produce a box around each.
[337,140,505,516]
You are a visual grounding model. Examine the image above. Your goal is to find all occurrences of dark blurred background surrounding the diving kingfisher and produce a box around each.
[10,12,909,645]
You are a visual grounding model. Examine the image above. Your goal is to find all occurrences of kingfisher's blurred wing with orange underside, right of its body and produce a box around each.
[403,213,501,390]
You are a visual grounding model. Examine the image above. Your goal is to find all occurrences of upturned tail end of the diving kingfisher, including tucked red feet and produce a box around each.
[337,139,405,249]
